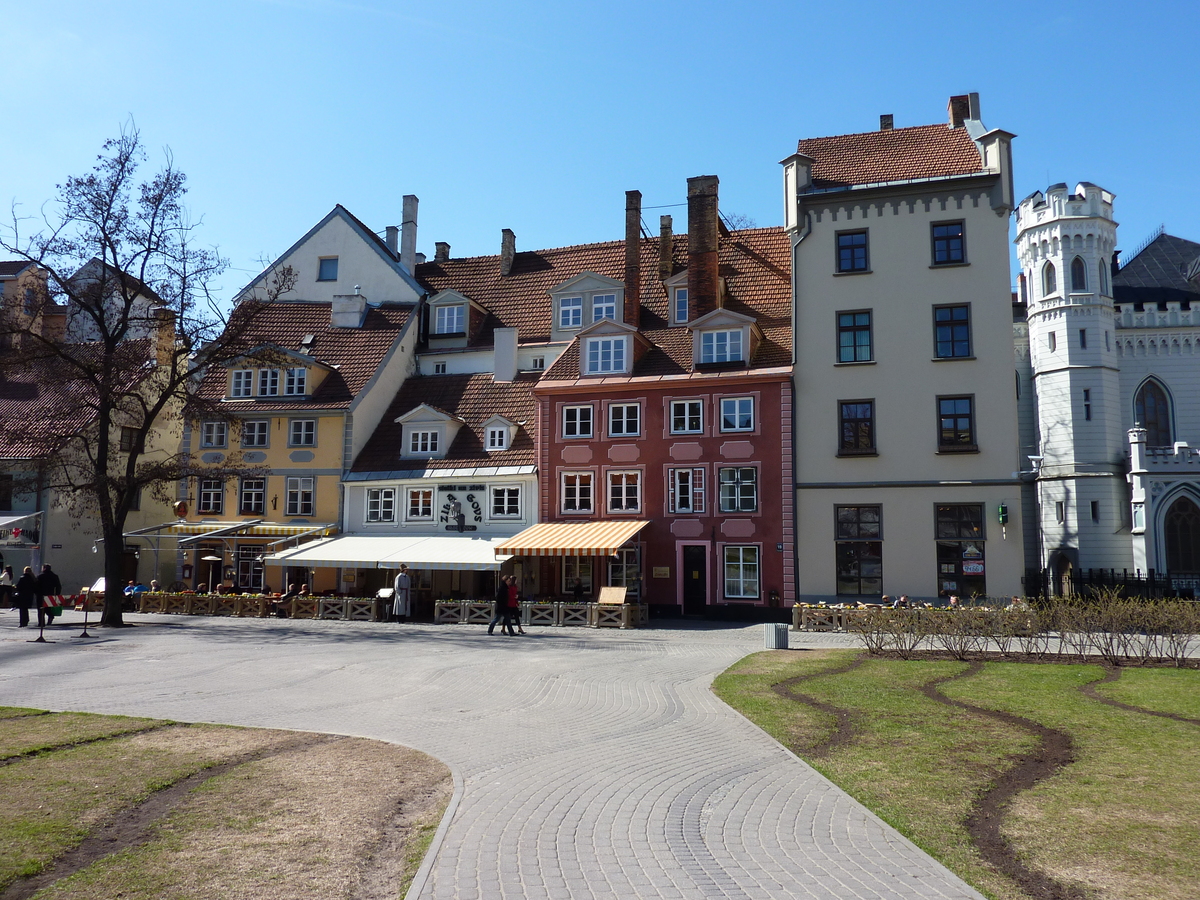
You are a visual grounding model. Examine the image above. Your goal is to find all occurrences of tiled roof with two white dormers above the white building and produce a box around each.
[350,373,538,473]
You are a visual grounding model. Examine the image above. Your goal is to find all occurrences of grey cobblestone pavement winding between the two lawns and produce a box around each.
[0,613,980,900]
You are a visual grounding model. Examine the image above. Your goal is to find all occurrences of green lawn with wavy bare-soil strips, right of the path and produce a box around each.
[714,650,1200,900]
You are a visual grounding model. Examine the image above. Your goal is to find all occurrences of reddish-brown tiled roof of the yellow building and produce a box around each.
[200,300,416,413]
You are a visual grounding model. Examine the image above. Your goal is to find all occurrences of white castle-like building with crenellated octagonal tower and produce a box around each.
[1015,181,1200,592]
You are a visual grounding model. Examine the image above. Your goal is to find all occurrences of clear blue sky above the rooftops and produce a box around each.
[0,0,1200,296]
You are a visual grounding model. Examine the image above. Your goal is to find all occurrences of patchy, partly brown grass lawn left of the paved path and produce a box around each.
[0,708,451,900]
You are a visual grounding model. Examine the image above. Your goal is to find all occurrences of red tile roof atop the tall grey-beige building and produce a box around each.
[798,125,983,187]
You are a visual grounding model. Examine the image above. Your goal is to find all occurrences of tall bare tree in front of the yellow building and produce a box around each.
[0,127,294,625]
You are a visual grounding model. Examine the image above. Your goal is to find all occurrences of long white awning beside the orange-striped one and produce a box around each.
[263,534,509,570]
